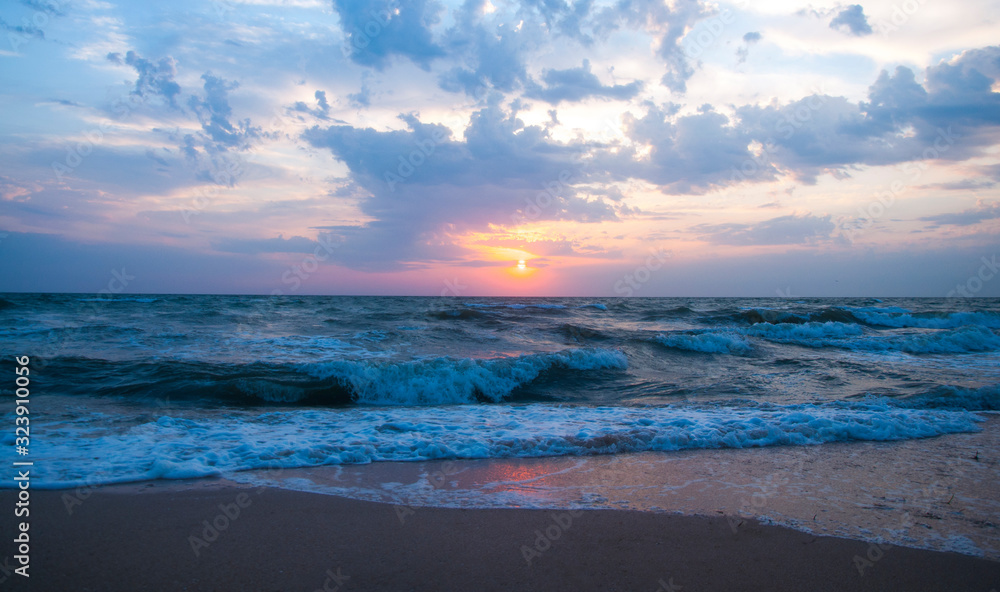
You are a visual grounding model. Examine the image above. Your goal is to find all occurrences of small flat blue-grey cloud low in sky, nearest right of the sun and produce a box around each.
[694,214,835,246]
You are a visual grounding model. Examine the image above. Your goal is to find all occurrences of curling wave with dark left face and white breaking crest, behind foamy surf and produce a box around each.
[43,348,628,406]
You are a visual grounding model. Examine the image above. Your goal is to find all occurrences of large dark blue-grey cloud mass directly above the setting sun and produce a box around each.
[304,103,617,269]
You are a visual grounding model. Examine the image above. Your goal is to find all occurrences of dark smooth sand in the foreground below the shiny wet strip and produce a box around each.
[0,481,1000,592]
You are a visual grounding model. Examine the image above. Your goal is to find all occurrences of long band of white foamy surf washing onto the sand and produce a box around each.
[0,401,981,488]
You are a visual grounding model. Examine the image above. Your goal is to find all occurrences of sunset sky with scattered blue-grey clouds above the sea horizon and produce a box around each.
[0,0,1000,298]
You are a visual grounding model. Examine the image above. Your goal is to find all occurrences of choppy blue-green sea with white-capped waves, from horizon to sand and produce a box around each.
[0,294,1000,488]
